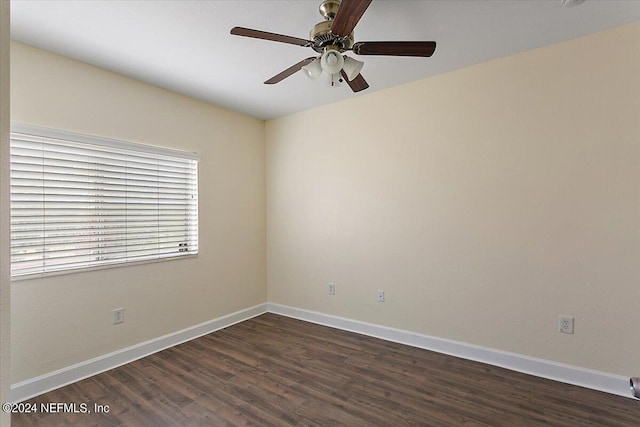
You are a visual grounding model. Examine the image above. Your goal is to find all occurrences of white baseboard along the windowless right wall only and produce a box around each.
[267,303,633,398]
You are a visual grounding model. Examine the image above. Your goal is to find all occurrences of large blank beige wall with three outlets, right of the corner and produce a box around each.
[266,24,640,375]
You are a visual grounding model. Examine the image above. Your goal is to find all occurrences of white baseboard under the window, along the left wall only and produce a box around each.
[11,304,267,402]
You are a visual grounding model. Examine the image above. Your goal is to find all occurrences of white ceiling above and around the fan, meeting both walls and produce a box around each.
[11,0,640,119]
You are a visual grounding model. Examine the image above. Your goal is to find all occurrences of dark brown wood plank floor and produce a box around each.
[12,314,640,427]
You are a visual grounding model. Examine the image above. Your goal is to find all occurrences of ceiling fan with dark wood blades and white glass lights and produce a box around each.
[231,0,436,92]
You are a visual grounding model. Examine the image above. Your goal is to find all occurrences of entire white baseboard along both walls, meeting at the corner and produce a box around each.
[11,303,633,402]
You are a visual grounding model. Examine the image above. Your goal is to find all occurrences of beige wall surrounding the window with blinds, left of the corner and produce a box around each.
[11,42,267,383]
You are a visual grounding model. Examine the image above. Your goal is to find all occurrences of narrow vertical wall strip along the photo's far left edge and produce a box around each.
[0,0,11,426]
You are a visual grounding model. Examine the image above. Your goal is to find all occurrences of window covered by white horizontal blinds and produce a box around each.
[11,124,198,277]
